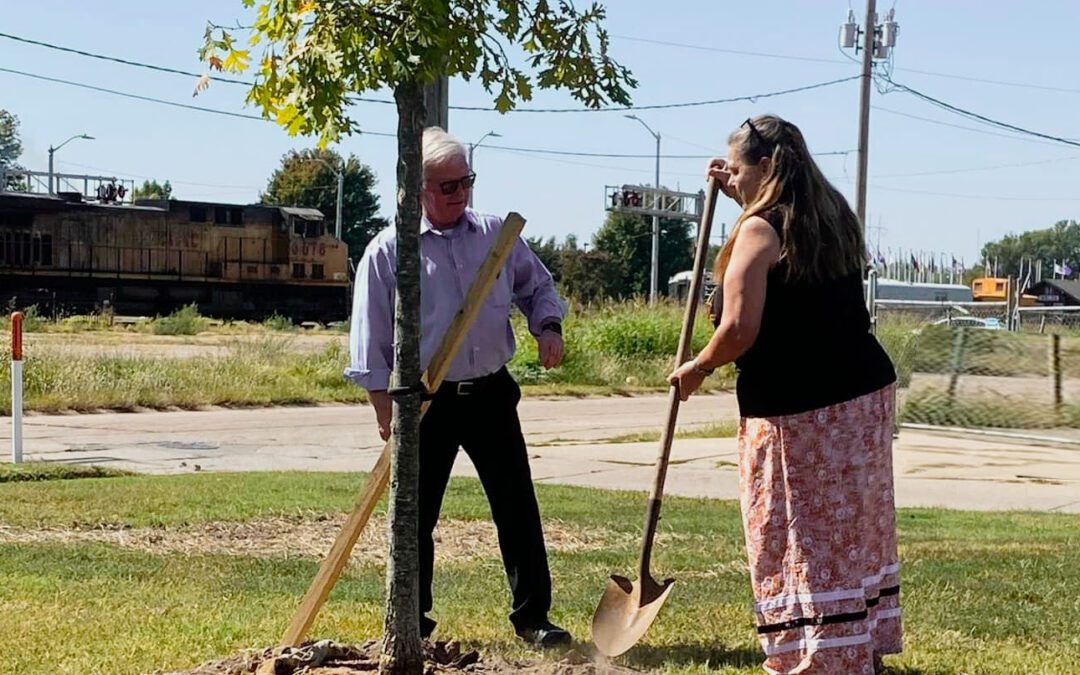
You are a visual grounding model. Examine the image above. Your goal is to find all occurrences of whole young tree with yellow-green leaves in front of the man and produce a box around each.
[201,0,636,674]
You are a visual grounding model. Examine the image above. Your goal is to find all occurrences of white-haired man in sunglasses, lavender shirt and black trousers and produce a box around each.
[346,127,570,647]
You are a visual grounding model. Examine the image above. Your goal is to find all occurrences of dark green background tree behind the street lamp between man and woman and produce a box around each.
[593,212,693,298]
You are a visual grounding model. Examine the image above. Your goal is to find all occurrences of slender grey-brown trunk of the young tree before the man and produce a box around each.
[379,82,424,675]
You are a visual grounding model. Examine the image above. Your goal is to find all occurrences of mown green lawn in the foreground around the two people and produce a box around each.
[0,473,1080,674]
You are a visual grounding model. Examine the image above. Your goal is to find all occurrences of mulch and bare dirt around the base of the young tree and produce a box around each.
[156,640,636,675]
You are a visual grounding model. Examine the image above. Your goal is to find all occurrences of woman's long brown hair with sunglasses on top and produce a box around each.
[713,114,867,284]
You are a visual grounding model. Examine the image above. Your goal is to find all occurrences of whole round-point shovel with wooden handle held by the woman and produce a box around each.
[593,178,719,657]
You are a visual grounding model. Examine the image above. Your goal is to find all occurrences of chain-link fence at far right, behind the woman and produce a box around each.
[874,300,1080,438]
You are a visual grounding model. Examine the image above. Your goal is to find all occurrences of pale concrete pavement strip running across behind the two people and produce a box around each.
[0,394,1080,513]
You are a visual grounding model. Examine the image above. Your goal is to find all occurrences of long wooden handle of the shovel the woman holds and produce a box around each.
[638,178,720,579]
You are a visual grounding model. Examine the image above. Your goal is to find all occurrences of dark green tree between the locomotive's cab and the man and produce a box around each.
[259,148,389,261]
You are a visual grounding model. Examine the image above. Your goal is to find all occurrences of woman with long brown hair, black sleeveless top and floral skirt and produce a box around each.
[670,116,902,674]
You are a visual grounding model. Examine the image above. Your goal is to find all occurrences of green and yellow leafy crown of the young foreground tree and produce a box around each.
[200,0,636,144]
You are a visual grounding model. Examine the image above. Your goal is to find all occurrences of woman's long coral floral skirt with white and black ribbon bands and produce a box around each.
[739,386,902,675]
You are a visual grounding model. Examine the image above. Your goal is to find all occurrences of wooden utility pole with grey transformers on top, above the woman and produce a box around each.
[840,0,900,237]
